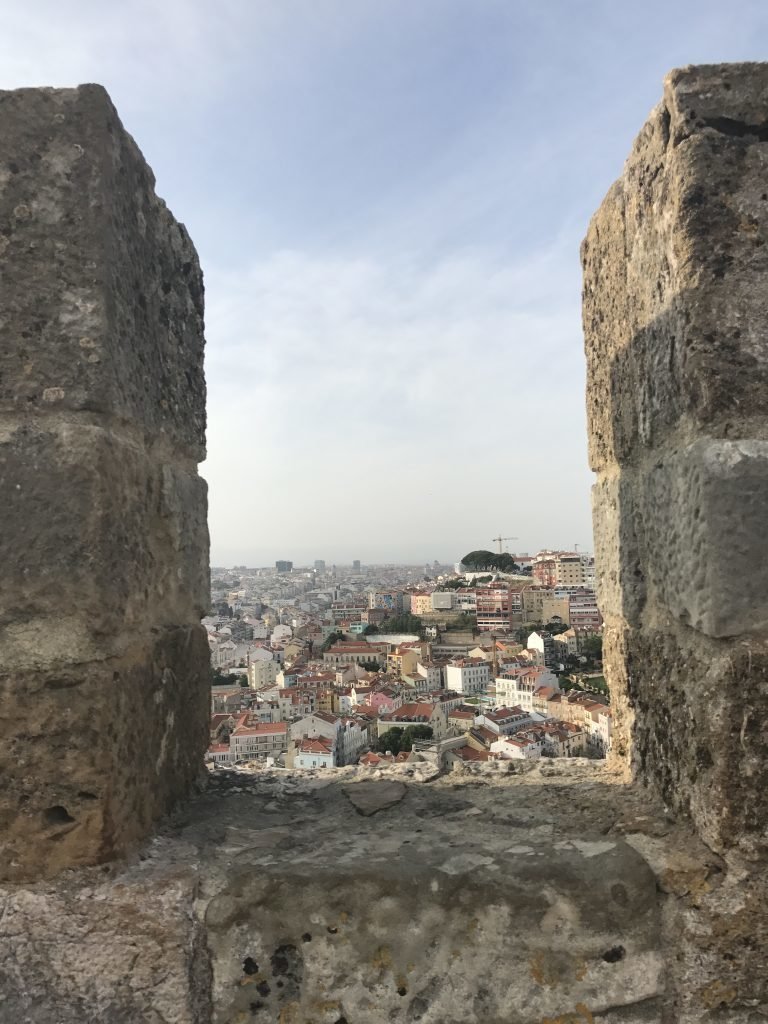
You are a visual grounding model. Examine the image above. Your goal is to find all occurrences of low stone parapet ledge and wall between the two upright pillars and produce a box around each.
[0,760,733,1024]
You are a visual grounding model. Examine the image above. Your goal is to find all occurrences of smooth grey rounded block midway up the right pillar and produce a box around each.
[647,439,768,637]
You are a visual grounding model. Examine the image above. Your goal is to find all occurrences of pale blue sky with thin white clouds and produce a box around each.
[0,0,768,565]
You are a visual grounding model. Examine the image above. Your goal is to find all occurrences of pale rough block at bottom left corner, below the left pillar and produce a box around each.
[0,864,211,1024]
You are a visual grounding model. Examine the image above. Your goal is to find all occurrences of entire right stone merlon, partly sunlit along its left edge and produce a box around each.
[582,63,768,857]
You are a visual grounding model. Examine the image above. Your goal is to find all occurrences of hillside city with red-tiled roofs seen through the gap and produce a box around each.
[203,537,611,771]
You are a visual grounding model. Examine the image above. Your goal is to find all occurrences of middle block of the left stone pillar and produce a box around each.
[0,418,210,669]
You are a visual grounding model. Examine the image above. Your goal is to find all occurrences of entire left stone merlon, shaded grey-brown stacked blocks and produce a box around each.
[0,85,209,879]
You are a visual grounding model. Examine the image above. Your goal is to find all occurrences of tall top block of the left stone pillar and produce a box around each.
[0,85,205,462]
